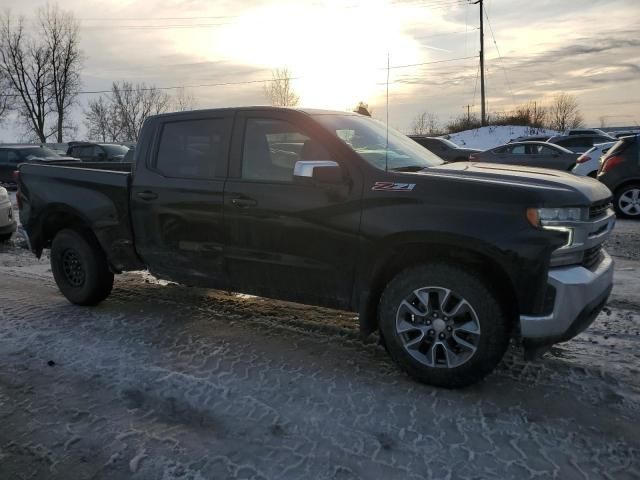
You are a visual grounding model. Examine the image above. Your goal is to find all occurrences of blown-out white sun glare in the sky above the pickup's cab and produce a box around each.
[174,1,424,109]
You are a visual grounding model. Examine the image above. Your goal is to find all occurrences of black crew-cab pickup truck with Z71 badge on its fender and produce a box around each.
[18,107,615,387]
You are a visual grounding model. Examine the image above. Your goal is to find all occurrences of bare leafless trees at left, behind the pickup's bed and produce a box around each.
[0,4,196,143]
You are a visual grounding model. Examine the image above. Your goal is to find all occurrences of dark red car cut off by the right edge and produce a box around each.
[598,135,640,219]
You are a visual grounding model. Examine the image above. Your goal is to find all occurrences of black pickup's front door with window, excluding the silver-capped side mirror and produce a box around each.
[224,110,361,308]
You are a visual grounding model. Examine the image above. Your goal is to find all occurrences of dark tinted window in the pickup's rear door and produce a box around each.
[154,118,228,179]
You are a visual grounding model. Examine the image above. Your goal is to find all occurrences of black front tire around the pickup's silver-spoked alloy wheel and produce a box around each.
[378,263,510,388]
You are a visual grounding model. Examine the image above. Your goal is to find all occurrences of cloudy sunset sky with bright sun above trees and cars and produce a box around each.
[0,0,640,141]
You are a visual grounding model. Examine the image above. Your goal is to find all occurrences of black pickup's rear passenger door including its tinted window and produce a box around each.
[131,111,233,288]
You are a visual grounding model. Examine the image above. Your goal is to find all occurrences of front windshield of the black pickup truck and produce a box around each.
[313,114,444,171]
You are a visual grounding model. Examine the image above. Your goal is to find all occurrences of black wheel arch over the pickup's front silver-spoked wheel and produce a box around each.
[358,238,520,335]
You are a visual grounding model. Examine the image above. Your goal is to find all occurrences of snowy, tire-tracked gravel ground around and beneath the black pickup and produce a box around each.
[0,212,640,480]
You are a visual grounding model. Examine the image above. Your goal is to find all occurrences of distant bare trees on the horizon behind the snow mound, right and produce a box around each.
[411,92,584,136]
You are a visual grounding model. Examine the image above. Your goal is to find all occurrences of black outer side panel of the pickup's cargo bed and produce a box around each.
[18,162,140,271]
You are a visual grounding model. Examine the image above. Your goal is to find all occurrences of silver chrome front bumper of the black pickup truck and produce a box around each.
[520,250,613,344]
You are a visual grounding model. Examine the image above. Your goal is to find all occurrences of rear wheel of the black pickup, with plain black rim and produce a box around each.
[51,229,113,305]
